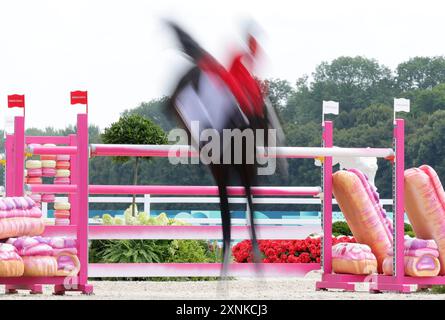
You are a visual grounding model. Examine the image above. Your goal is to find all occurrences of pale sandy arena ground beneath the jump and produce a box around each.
[0,273,445,300]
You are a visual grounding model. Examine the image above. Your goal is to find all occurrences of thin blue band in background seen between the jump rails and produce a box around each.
[48,210,408,222]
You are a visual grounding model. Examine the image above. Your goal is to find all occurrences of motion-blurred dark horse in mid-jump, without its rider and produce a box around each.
[169,23,284,275]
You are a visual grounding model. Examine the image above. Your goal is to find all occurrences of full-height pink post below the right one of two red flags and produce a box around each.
[74,113,88,288]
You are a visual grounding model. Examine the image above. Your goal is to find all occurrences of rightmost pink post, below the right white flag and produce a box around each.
[393,119,405,283]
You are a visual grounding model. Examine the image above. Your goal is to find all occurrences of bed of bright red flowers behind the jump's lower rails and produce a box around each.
[232,236,355,263]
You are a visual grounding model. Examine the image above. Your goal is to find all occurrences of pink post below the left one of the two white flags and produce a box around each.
[322,121,333,274]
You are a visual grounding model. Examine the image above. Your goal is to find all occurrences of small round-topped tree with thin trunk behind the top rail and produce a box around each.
[102,114,167,216]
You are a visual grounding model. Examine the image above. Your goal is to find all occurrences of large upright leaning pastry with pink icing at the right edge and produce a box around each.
[405,165,445,275]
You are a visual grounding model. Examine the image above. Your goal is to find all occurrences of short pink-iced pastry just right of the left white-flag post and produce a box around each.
[332,243,377,275]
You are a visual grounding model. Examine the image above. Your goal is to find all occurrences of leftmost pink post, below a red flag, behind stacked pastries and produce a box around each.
[13,116,25,197]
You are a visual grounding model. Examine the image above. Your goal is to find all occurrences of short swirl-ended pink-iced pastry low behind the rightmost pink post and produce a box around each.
[383,237,440,277]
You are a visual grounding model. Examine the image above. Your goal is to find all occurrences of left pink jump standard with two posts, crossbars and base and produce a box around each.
[0,95,93,294]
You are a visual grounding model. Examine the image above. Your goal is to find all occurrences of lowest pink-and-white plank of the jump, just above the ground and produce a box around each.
[88,263,320,278]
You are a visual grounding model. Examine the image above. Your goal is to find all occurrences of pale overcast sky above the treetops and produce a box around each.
[0,0,445,128]
